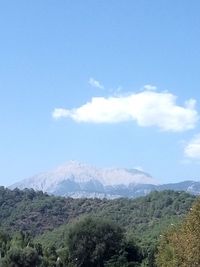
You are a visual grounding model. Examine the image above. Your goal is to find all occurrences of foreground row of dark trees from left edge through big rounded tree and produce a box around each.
[0,217,142,267]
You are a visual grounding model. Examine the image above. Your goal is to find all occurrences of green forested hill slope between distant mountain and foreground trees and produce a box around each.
[0,187,195,240]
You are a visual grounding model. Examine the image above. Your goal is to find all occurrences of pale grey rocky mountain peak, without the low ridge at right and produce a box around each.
[10,161,157,198]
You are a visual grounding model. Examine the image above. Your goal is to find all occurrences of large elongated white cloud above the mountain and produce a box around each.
[53,90,198,132]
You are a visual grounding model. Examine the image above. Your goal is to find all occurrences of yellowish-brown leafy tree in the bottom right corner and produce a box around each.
[156,199,200,267]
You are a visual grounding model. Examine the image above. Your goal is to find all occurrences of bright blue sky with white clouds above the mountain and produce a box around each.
[0,0,200,186]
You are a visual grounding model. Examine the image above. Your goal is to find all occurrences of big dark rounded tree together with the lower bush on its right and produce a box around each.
[63,217,142,267]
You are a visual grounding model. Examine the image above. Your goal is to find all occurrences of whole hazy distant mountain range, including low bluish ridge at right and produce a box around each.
[9,161,200,199]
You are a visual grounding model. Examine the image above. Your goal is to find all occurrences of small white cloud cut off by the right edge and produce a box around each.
[184,134,200,160]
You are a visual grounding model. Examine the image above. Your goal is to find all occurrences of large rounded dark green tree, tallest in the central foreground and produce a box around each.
[68,217,123,267]
